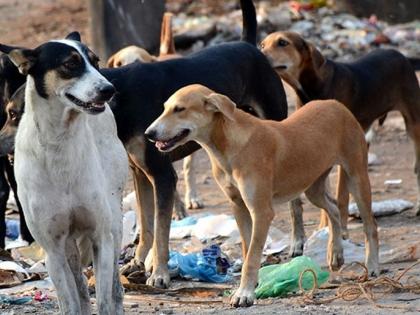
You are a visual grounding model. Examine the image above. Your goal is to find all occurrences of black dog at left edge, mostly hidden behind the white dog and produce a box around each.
[0,55,34,248]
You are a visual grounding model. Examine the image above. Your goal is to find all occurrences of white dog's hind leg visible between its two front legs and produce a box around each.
[65,238,91,315]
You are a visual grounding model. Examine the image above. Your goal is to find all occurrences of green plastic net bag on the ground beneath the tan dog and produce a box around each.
[255,256,330,299]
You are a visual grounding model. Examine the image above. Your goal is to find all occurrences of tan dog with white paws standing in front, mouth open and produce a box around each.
[145,85,379,306]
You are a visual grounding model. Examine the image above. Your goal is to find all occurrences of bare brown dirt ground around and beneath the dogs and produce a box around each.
[0,0,420,314]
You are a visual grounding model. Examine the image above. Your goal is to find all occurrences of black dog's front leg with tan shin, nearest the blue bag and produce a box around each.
[147,167,176,288]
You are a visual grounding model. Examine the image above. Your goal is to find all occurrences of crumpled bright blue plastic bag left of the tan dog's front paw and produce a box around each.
[168,245,231,283]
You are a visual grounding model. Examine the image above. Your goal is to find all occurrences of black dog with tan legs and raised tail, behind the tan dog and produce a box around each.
[102,0,287,287]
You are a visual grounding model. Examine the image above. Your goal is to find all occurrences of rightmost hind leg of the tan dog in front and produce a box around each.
[346,168,379,275]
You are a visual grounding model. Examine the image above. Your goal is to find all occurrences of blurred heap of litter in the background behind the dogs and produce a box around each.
[169,1,420,61]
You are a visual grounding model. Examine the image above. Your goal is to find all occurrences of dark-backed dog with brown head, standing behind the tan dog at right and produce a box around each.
[261,32,420,236]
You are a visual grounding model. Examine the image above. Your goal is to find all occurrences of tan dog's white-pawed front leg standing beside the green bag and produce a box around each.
[230,183,274,307]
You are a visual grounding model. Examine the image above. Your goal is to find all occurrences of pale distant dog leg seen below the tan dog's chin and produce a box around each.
[183,153,203,209]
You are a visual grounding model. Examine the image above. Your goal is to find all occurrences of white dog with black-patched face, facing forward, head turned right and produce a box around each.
[0,32,128,314]
